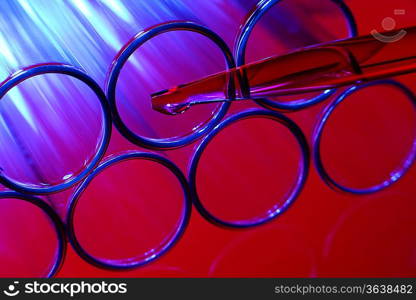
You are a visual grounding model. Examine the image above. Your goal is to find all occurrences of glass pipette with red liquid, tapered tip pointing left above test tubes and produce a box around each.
[152,27,416,115]
